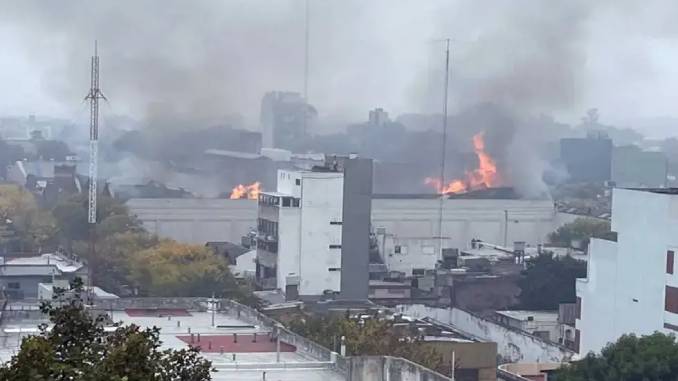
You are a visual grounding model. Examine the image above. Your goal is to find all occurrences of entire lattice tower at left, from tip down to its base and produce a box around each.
[85,41,106,303]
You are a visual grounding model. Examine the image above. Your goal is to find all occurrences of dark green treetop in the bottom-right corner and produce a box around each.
[549,333,678,381]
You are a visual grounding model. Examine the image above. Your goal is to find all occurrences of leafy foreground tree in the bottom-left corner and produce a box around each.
[0,279,213,381]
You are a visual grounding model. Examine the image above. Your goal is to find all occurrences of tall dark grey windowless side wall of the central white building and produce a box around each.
[339,158,372,300]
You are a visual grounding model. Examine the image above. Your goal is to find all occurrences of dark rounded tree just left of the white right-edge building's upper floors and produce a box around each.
[518,254,586,310]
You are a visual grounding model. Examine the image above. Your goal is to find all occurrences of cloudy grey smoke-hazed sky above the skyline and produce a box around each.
[0,0,678,134]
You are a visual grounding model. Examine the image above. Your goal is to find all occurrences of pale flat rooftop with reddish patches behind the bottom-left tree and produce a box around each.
[0,302,345,381]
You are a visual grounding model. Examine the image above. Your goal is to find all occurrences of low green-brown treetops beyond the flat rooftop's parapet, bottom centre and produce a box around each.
[289,316,449,371]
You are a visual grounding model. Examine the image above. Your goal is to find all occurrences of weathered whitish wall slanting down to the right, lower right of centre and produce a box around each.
[397,305,574,362]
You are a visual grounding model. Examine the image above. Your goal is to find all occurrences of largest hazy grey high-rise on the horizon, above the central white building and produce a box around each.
[260,91,316,150]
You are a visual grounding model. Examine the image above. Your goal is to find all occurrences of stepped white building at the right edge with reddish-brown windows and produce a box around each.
[575,189,678,355]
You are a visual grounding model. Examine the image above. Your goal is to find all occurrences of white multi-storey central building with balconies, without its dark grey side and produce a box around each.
[257,170,344,295]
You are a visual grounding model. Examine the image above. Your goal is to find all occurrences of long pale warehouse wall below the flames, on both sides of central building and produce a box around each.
[127,199,561,248]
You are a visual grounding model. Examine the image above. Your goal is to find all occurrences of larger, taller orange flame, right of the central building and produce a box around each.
[424,132,501,194]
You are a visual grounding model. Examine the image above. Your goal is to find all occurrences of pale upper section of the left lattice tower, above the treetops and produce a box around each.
[85,41,106,224]
